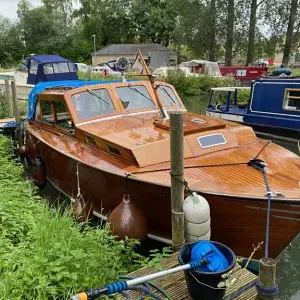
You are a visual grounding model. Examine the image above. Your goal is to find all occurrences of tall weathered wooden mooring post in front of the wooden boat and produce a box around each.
[170,112,185,251]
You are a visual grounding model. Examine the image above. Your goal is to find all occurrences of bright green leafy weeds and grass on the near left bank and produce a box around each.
[0,136,142,300]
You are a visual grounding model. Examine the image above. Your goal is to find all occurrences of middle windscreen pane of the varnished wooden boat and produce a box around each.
[116,85,155,111]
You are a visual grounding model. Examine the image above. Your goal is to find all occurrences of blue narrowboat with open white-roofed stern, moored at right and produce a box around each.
[206,78,300,139]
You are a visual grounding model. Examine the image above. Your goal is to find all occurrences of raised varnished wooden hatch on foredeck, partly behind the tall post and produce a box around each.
[153,115,226,135]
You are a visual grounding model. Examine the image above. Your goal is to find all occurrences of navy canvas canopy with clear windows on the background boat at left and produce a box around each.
[26,55,78,84]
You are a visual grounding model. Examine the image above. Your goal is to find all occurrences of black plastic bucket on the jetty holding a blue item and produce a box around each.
[178,241,236,300]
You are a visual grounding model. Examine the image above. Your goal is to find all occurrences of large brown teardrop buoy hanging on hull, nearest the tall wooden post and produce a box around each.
[107,194,148,240]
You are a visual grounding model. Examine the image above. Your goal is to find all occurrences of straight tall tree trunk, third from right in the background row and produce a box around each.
[225,0,234,66]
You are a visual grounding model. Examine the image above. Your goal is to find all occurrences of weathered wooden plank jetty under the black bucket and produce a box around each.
[117,253,257,300]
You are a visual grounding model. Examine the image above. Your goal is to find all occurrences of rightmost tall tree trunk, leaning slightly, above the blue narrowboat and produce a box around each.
[282,0,298,66]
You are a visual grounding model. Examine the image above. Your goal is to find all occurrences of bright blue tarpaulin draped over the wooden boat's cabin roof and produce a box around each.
[27,80,120,120]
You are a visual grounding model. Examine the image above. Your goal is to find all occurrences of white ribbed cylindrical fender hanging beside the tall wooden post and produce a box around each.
[183,193,210,242]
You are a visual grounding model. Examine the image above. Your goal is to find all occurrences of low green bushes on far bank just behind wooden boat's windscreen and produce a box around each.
[158,71,239,96]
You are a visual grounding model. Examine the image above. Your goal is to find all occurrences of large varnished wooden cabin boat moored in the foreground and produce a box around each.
[25,81,300,257]
